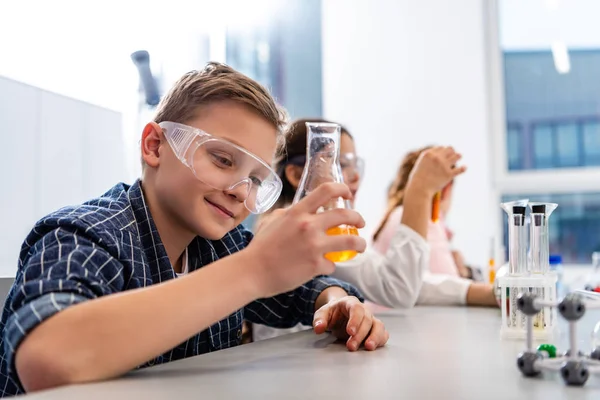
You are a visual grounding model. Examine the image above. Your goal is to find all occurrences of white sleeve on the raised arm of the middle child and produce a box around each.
[333,225,429,308]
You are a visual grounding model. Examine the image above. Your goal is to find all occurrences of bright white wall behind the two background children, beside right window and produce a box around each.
[322,0,499,265]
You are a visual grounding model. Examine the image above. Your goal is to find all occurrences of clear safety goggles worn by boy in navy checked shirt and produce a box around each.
[158,121,282,214]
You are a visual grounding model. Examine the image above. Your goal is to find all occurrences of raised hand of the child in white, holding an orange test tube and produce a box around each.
[407,147,466,195]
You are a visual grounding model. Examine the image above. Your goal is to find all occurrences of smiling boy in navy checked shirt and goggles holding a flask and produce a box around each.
[0,63,388,396]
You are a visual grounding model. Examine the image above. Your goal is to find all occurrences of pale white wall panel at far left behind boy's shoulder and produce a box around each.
[0,77,127,276]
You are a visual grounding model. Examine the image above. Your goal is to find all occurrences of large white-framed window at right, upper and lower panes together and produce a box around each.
[489,0,600,264]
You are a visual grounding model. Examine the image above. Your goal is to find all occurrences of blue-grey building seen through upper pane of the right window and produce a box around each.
[502,47,600,169]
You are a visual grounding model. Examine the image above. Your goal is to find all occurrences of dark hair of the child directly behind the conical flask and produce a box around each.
[271,118,353,210]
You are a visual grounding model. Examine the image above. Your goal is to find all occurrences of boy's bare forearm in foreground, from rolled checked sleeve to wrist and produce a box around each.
[15,251,262,391]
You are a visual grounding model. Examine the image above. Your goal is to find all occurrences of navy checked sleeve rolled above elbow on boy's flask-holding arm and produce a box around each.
[3,228,124,382]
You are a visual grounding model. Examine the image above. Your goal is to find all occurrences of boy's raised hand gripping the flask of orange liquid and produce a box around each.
[244,183,366,297]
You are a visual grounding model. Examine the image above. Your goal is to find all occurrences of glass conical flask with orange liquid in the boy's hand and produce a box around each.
[294,122,358,262]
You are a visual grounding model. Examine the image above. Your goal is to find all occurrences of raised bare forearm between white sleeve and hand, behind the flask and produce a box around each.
[402,182,434,238]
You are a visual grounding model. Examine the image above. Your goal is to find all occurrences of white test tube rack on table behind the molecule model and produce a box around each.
[498,272,558,340]
